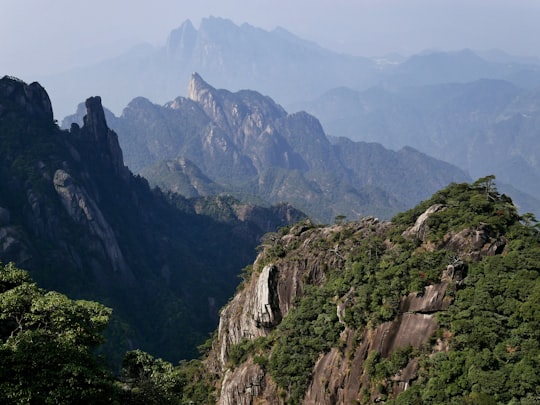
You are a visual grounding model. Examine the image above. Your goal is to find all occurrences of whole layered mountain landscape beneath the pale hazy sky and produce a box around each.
[0,14,540,405]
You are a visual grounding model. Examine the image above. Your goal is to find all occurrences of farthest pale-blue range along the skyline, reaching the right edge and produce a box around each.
[38,17,540,118]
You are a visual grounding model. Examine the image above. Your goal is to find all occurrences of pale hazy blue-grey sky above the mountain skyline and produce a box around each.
[0,0,540,81]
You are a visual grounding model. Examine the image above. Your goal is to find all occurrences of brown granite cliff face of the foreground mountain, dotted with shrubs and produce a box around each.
[206,188,515,404]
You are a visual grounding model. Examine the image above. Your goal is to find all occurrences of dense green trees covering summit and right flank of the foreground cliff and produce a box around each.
[388,176,540,404]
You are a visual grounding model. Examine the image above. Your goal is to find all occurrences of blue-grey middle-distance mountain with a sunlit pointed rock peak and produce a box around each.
[63,73,468,222]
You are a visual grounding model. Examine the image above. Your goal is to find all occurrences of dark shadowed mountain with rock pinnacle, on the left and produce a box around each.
[0,77,304,361]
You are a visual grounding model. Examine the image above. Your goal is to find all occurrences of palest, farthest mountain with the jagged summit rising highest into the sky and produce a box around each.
[40,17,376,117]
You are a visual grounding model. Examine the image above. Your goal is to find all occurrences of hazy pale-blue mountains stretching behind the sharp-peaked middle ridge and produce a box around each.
[42,17,540,216]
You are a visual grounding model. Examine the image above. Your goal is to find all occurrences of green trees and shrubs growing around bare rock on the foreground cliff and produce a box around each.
[247,176,540,404]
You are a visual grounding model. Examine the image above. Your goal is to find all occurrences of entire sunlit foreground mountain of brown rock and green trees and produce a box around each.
[116,176,540,405]
